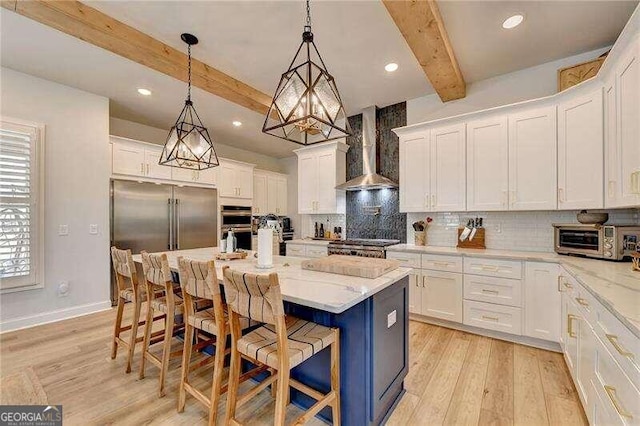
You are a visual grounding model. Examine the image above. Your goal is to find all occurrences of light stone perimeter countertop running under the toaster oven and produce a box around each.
[387,244,640,338]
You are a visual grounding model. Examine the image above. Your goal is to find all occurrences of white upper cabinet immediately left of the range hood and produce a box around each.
[294,141,349,214]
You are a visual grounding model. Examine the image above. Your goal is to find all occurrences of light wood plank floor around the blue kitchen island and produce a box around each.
[0,310,586,425]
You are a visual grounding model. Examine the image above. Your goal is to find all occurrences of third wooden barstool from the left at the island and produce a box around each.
[178,257,266,425]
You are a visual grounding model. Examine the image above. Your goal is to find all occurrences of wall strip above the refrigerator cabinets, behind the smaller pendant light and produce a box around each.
[109,117,285,173]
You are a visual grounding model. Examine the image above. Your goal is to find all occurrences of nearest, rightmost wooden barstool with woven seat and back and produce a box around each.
[222,266,340,426]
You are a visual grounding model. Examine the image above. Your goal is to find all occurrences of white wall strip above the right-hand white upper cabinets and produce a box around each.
[407,47,609,125]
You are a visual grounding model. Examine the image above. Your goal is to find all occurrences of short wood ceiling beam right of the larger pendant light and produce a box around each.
[382,0,467,102]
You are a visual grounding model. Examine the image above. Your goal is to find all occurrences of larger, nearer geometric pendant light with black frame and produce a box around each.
[262,0,351,145]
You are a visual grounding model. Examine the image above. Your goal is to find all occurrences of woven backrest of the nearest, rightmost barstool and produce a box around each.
[222,266,284,324]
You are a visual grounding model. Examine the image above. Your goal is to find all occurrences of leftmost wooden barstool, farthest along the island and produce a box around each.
[111,247,162,373]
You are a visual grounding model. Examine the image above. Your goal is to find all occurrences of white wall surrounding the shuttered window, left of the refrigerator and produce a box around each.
[0,68,111,331]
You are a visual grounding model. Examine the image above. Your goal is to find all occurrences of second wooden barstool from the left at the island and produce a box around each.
[139,251,184,397]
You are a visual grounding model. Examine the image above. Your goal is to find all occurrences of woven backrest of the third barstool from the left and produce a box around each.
[178,256,220,300]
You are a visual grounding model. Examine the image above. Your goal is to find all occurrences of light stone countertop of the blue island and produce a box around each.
[133,247,411,314]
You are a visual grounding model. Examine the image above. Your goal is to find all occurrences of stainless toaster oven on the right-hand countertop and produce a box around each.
[553,224,640,260]
